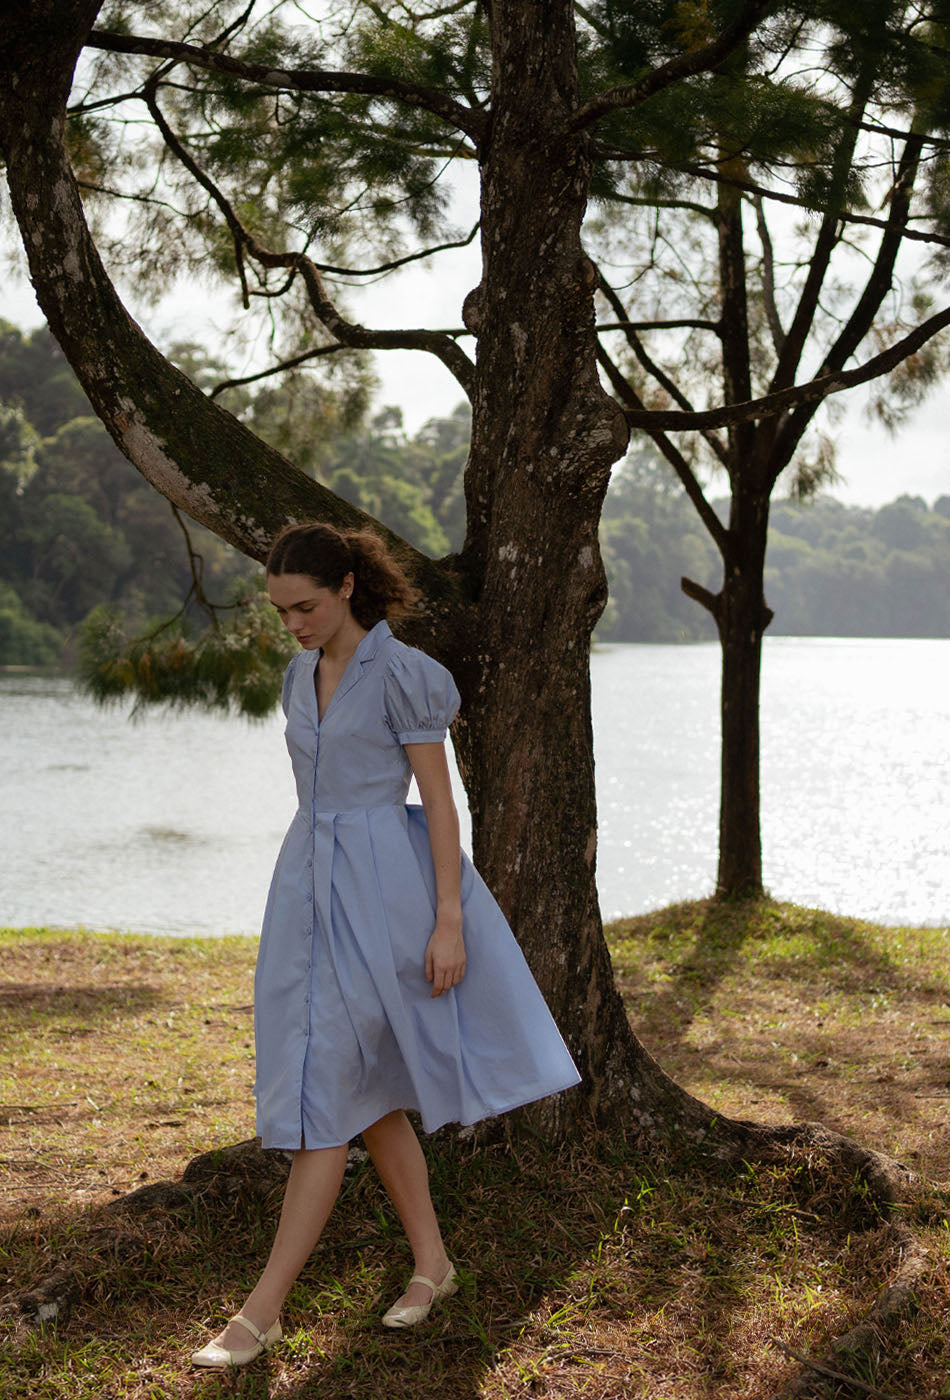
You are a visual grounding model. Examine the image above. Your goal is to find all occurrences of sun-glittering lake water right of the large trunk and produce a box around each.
[590,637,950,923]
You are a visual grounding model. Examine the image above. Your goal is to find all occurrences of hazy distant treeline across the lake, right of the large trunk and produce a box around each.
[597,448,950,641]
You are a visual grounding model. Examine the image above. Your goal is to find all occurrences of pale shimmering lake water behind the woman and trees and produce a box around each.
[0,637,950,934]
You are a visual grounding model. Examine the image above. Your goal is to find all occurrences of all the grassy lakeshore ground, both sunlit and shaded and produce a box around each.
[0,903,950,1400]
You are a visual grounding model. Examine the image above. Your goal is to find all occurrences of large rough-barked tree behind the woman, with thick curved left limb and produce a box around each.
[0,0,936,1142]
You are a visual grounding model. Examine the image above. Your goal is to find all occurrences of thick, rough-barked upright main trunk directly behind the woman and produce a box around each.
[444,3,654,1131]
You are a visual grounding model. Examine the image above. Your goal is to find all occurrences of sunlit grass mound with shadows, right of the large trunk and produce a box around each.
[610,900,950,1180]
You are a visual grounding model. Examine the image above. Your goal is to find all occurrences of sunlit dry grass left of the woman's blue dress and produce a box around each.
[0,930,256,1221]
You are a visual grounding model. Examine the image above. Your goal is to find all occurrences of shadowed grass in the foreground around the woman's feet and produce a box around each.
[3,1134,901,1400]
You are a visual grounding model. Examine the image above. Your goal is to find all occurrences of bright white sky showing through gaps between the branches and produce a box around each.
[0,207,950,507]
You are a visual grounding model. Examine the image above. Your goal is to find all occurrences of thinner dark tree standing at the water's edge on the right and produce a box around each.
[590,0,950,896]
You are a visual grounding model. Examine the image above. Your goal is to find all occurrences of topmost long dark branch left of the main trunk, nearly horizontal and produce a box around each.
[87,29,487,143]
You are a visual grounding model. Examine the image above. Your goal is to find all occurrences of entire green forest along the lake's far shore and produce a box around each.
[0,322,950,665]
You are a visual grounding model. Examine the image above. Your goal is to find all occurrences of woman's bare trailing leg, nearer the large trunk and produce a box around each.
[362,1110,449,1306]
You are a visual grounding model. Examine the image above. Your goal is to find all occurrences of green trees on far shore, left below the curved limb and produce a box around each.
[0,326,280,665]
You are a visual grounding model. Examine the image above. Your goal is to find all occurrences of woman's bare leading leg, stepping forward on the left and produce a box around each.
[214,1144,347,1351]
